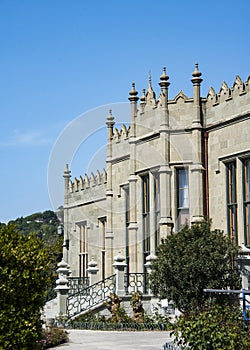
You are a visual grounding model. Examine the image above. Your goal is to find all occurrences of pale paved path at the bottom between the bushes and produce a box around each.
[54,329,170,350]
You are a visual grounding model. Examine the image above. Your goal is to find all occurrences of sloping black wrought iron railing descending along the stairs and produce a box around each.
[67,275,115,318]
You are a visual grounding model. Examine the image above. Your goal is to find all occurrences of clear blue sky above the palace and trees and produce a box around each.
[0,0,250,222]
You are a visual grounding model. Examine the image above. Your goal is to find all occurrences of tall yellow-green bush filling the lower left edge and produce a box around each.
[0,224,50,350]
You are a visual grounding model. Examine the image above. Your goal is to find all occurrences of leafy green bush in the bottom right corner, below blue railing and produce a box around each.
[174,304,250,350]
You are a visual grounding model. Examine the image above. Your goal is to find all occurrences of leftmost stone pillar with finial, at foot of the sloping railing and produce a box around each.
[55,260,70,316]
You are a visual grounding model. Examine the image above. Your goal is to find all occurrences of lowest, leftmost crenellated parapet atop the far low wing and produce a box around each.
[69,169,107,193]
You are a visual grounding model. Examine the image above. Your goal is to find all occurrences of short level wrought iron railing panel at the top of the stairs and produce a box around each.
[124,273,148,294]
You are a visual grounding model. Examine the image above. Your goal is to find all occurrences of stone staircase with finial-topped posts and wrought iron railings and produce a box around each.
[44,254,155,320]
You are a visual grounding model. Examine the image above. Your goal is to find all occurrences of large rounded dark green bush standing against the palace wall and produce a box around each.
[151,221,240,312]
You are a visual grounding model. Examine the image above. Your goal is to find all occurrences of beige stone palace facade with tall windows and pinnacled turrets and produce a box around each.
[64,64,250,288]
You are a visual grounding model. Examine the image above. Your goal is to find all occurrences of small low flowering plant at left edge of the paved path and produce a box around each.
[37,327,69,350]
